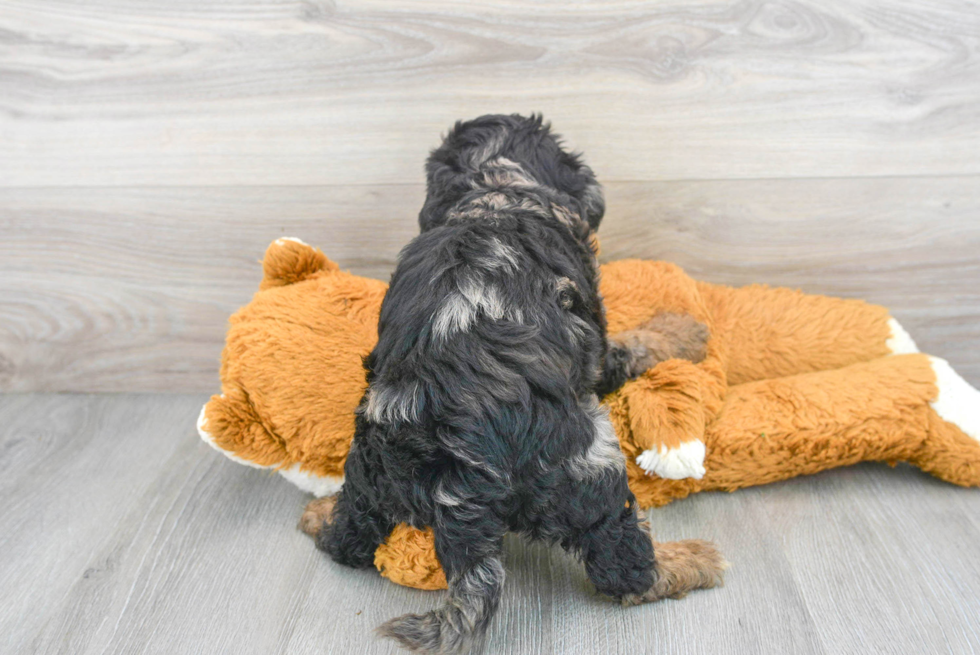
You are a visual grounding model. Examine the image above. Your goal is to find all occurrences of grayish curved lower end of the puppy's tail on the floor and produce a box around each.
[378,557,504,654]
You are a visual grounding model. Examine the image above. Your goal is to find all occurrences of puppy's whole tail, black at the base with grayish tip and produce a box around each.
[378,494,505,653]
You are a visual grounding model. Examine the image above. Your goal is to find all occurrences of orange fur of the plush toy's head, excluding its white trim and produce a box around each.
[198,239,387,484]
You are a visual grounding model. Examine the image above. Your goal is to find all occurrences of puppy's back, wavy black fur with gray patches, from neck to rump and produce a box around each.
[364,215,601,476]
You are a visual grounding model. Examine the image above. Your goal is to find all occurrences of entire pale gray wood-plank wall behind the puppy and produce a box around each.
[0,0,980,391]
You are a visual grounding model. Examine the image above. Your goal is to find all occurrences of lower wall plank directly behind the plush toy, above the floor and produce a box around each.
[0,176,980,392]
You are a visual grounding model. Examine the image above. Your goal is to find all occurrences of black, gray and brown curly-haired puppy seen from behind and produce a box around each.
[304,115,725,653]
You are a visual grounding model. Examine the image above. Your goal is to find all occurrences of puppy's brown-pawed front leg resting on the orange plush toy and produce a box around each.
[597,312,710,396]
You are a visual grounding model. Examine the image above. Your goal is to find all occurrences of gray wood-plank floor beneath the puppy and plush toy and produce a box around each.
[0,394,980,655]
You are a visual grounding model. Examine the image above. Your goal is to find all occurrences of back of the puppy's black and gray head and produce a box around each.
[419,114,605,231]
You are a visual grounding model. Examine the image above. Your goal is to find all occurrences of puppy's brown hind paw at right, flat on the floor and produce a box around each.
[623,539,728,605]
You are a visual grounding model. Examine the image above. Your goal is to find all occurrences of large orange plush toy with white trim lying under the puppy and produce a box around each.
[198,239,980,589]
